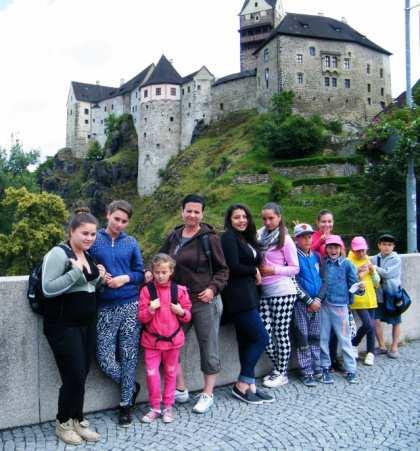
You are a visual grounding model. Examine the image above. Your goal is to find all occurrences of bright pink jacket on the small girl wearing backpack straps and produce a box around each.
[139,282,191,351]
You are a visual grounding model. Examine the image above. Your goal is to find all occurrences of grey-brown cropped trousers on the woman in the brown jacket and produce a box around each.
[187,295,223,375]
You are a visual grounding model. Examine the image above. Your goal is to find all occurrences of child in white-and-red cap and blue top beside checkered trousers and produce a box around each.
[293,224,322,387]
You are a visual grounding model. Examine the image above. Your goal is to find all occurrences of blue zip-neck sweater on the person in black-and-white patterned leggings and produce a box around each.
[89,229,144,307]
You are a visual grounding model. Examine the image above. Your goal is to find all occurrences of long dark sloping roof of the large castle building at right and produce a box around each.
[254,13,391,55]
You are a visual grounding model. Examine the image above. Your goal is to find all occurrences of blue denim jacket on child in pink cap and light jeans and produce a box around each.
[319,257,359,305]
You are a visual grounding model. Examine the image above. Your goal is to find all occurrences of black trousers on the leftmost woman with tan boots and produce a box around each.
[44,322,96,423]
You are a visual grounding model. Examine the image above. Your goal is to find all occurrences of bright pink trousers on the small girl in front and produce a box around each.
[144,348,180,410]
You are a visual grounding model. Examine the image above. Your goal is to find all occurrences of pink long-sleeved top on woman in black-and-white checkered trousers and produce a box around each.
[261,235,299,285]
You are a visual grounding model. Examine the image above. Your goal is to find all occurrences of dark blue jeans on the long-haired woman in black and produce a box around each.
[232,309,269,384]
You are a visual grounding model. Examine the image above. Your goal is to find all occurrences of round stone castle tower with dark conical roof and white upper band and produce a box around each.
[137,55,183,196]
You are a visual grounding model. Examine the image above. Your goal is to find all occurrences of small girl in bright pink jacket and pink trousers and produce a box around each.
[139,254,191,423]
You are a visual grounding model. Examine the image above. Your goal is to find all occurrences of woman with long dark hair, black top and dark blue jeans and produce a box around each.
[222,204,274,404]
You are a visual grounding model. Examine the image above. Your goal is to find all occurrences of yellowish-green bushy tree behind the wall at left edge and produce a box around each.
[0,188,68,275]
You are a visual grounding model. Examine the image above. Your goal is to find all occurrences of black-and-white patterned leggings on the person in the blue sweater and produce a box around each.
[96,300,140,406]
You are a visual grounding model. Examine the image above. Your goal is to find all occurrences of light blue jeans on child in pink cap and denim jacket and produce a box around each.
[321,301,357,373]
